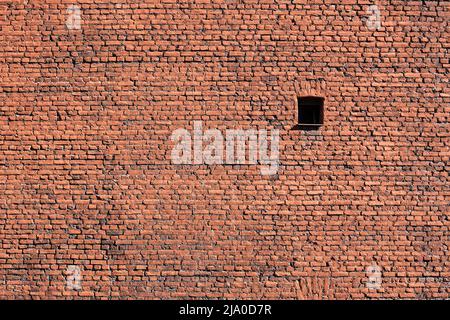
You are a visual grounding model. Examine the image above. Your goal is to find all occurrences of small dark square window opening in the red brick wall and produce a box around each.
[297,97,325,127]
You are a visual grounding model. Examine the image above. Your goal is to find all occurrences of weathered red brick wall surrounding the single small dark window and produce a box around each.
[0,0,450,299]
